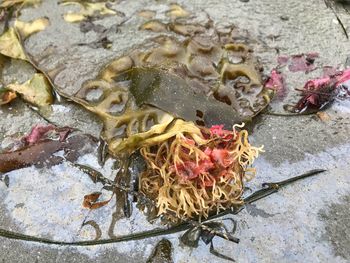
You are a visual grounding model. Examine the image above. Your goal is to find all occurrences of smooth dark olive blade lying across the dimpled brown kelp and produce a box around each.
[115,68,249,127]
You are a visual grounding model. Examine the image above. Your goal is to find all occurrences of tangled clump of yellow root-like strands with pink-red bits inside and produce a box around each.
[140,120,262,218]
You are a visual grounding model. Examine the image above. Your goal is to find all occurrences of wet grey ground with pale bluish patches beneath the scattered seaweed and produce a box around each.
[0,0,350,262]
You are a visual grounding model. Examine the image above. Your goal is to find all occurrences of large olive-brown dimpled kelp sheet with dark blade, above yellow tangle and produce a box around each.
[71,12,273,155]
